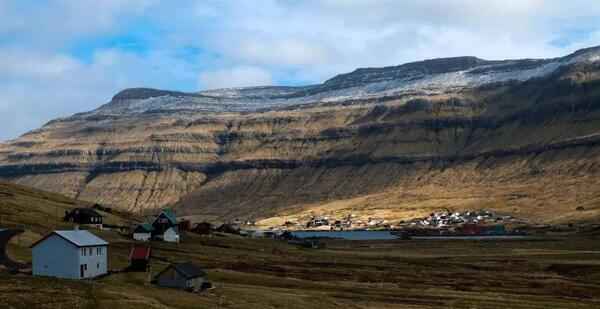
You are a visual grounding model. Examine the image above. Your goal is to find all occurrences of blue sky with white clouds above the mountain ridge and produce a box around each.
[0,0,600,141]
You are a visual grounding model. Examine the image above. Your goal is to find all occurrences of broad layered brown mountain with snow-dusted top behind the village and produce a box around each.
[0,47,600,224]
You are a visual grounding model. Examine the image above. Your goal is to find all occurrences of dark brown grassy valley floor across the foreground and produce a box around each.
[0,232,600,309]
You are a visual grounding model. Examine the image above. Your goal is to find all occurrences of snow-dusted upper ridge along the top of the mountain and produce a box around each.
[81,47,600,115]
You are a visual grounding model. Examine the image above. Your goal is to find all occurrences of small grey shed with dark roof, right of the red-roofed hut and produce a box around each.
[155,262,209,292]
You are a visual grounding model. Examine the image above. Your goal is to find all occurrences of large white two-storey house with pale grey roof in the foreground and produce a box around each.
[31,230,108,279]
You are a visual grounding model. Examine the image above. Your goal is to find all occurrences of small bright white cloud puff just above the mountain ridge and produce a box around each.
[199,66,273,89]
